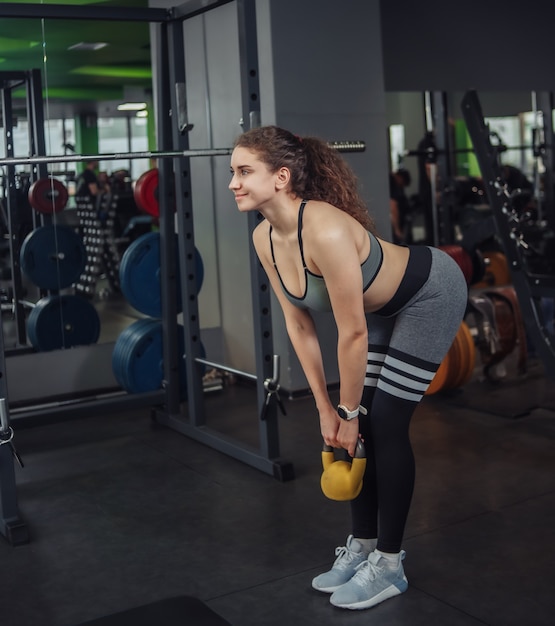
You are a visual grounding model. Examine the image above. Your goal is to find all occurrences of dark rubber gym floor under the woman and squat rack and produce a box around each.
[0,354,555,626]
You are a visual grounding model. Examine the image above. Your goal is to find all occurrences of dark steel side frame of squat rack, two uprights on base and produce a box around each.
[148,0,294,481]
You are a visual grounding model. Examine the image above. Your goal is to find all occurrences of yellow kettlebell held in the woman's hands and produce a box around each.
[320,439,366,501]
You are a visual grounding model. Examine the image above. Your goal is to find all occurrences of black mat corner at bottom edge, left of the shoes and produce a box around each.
[79,596,231,626]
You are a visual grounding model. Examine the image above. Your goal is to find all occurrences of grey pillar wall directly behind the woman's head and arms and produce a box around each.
[257,0,390,392]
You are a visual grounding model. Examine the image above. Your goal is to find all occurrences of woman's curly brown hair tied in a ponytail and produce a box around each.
[234,126,376,234]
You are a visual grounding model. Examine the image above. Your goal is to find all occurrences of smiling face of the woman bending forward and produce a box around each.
[229,147,276,211]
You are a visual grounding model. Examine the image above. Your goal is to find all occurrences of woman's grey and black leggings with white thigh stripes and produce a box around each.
[351,248,468,552]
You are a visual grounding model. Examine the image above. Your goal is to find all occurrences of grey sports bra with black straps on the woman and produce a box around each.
[269,200,383,311]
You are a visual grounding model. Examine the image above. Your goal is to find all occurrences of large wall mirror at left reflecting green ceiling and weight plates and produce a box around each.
[0,14,157,355]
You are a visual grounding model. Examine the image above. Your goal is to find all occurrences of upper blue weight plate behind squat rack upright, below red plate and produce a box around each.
[119,232,204,317]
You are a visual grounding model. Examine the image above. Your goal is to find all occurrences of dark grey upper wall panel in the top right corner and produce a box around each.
[380,0,555,92]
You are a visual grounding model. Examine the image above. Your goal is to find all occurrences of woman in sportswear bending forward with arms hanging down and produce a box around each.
[229,126,467,609]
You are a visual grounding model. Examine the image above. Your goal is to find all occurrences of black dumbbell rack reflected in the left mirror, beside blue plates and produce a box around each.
[75,193,120,298]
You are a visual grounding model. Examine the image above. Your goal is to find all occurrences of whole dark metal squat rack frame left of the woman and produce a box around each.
[0,0,288,544]
